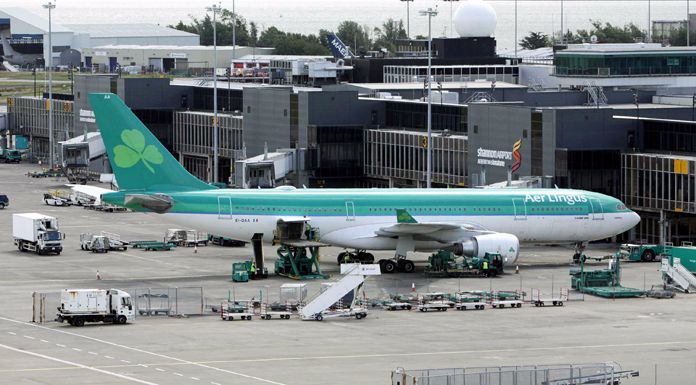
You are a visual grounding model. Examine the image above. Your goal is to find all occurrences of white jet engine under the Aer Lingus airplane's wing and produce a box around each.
[454,233,520,265]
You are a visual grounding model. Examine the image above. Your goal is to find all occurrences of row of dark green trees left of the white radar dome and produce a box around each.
[169,9,407,55]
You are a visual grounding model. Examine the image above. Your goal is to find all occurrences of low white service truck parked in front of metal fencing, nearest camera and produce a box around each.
[56,289,135,326]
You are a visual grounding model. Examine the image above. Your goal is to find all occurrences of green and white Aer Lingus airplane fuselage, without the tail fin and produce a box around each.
[103,188,638,260]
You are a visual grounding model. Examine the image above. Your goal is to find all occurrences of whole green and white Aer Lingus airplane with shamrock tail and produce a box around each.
[84,94,640,272]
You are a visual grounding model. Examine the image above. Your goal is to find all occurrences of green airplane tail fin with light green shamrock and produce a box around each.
[89,93,215,192]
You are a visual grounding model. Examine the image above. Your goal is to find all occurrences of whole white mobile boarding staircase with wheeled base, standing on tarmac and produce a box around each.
[299,263,381,321]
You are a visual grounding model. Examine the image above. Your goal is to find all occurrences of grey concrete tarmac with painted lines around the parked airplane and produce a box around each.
[0,164,696,385]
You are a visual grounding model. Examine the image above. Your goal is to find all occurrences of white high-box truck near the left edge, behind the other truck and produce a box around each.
[12,213,65,255]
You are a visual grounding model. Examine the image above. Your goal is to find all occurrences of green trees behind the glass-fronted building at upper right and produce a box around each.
[519,21,686,49]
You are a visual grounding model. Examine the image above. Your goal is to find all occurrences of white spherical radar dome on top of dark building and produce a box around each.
[452,0,498,37]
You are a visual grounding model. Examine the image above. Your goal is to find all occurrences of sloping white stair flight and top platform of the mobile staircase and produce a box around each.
[300,263,381,320]
